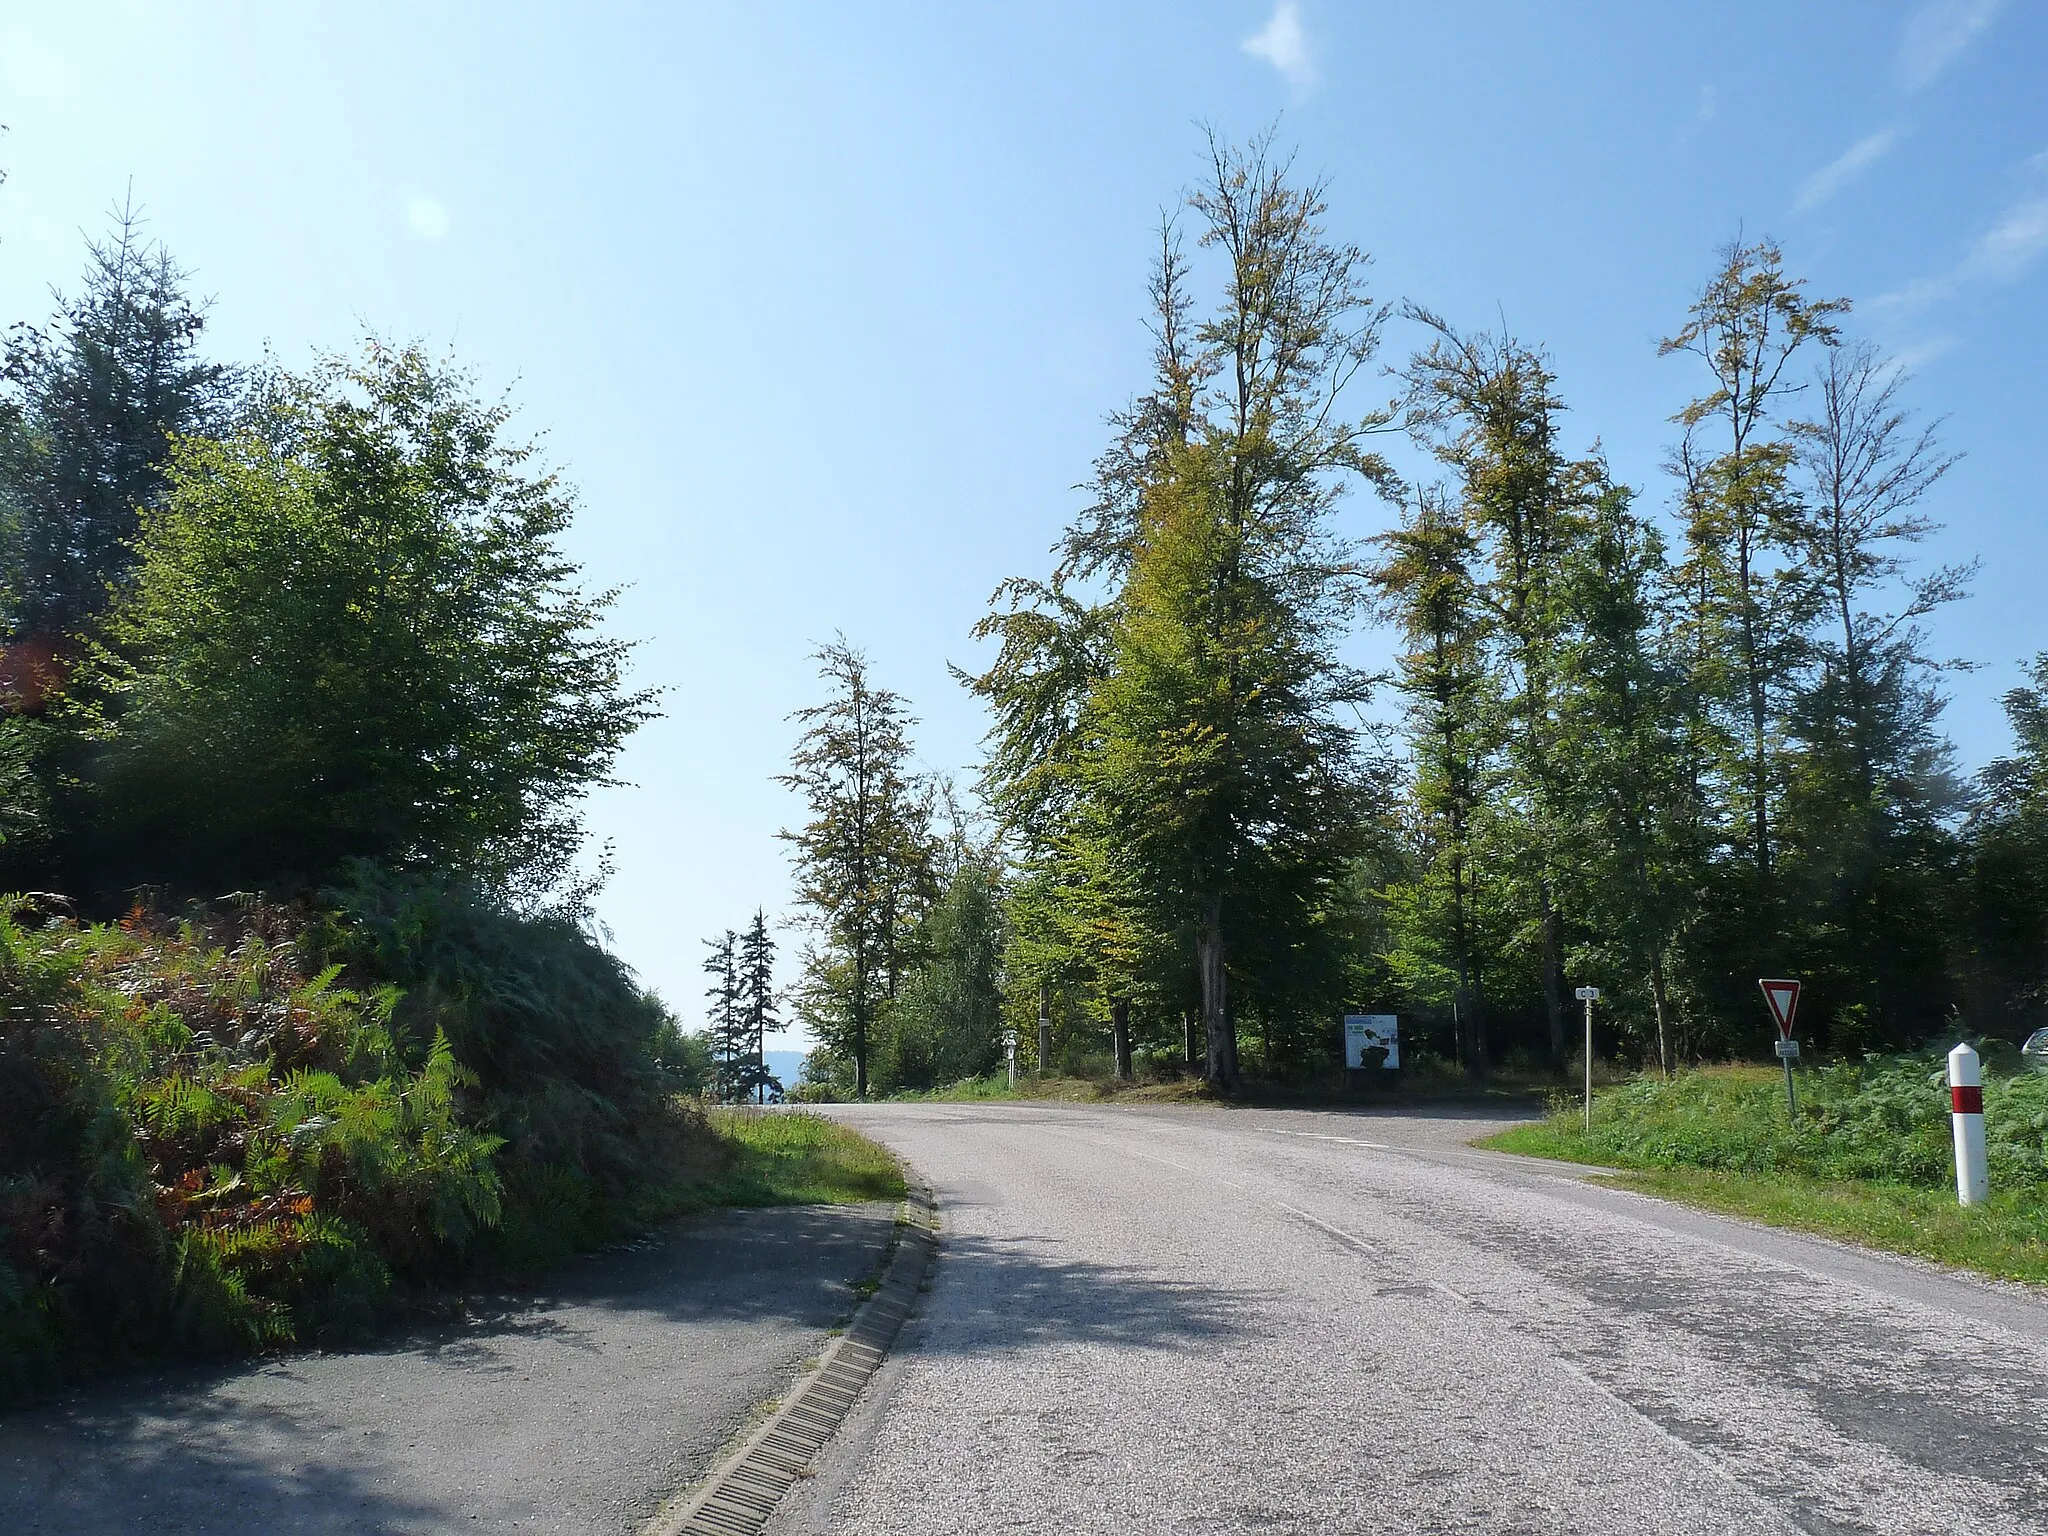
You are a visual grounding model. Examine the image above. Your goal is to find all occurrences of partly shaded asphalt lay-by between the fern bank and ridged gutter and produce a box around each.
[0,1204,895,1536]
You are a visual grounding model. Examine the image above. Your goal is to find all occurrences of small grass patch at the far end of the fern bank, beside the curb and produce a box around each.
[696,1108,903,1206]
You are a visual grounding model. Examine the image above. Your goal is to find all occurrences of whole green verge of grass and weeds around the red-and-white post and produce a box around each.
[1479,1057,2048,1286]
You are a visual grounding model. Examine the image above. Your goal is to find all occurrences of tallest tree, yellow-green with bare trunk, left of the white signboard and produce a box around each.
[979,137,1386,1092]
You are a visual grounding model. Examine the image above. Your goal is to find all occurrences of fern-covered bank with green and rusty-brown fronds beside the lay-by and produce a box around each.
[0,884,707,1397]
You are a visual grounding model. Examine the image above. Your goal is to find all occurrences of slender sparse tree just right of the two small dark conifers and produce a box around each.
[776,637,936,1098]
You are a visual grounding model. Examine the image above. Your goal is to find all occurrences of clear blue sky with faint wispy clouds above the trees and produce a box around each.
[0,0,2048,1048]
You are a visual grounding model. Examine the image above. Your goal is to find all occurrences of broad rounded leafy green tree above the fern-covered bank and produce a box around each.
[92,344,653,899]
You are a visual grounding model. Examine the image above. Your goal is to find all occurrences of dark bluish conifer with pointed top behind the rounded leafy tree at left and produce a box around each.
[0,203,236,635]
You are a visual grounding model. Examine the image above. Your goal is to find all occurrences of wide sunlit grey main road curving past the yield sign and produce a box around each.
[770,1104,2048,1536]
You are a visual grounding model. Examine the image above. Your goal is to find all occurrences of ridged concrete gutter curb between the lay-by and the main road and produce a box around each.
[641,1184,938,1536]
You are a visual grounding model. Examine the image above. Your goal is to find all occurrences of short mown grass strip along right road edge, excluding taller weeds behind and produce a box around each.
[1479,1069,2048,1286]
